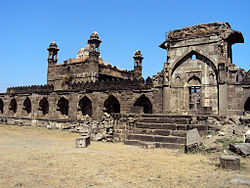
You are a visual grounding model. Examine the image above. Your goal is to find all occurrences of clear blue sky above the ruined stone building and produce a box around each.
[0,0,250,92]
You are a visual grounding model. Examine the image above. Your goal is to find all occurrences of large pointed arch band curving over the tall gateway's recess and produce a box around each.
[171,50,218,80]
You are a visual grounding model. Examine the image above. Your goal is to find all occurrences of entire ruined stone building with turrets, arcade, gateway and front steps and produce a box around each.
[0,23,250,148]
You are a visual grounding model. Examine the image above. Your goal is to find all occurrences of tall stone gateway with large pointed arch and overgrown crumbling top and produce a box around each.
[160,22,249,116]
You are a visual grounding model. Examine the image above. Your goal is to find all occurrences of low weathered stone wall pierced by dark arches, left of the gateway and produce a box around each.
[0,85,162,120]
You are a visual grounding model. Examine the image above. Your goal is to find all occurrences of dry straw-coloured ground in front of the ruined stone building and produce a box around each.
[0,125,250,188]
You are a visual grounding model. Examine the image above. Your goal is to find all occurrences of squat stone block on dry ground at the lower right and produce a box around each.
[220,155,240,170]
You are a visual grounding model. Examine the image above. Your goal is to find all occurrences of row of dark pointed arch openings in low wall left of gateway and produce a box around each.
[0,94,152,117]
